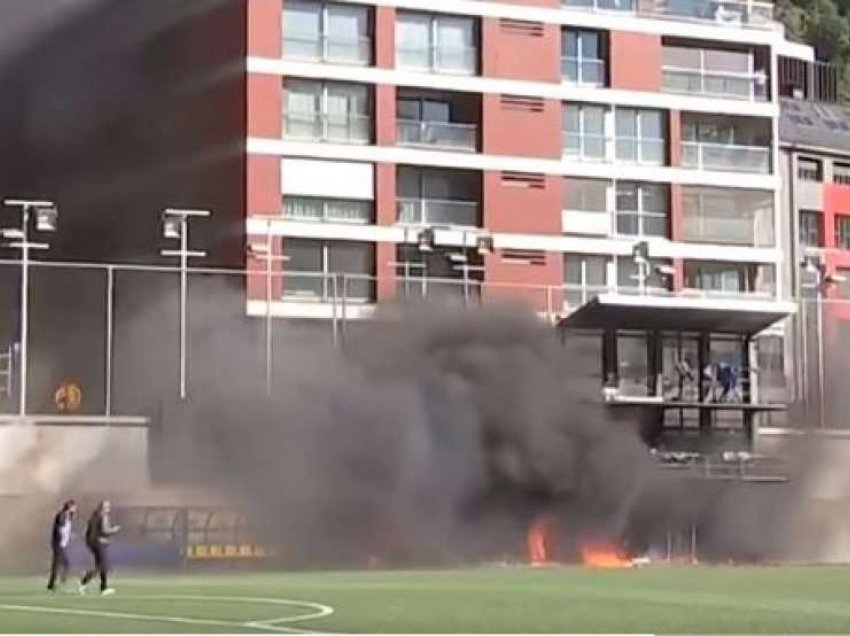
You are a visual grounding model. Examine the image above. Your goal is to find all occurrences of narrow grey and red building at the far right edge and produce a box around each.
[780,96,850,428]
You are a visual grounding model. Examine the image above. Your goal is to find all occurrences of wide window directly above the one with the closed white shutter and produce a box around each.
[284,80,372,143]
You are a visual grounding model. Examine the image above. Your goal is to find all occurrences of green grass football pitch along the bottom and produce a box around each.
[0,567,850,634]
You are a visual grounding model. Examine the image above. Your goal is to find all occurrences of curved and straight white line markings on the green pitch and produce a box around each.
[0,595,334,634]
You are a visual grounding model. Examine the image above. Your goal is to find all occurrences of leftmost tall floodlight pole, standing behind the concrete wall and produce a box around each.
[0,199,59,417]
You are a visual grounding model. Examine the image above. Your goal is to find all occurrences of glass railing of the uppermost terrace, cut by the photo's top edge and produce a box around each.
[562,0,773,29]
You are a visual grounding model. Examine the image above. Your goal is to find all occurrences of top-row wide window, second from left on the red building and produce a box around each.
[396,12,478,75]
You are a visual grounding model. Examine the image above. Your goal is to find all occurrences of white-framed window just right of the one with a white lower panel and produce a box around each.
[617,181,670,236]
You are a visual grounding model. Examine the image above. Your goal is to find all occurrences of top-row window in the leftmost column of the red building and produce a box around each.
[283,0,372,64]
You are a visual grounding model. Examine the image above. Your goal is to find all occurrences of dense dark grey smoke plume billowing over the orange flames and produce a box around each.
[169,305,651,562]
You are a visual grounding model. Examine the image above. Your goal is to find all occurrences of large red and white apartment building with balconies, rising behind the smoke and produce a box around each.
[237,0,812,450]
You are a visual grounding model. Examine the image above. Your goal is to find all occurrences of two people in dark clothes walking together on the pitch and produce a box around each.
[47,499,121,596]
